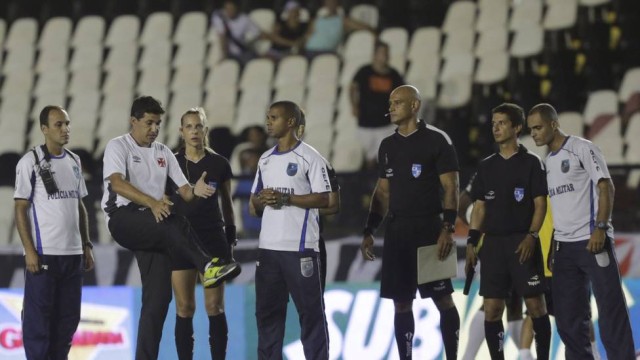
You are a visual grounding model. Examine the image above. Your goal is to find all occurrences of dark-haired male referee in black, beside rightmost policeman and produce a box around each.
[466,103,551,359]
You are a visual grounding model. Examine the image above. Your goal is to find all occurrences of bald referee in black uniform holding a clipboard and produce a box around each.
[361,85,460,359]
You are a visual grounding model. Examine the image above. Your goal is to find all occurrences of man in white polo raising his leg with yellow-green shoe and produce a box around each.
[102,96,240,359]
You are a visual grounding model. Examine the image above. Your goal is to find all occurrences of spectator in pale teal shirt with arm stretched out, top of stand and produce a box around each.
[305,0,374,57]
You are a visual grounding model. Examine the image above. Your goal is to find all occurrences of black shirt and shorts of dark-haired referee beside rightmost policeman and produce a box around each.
[471,145,547,299]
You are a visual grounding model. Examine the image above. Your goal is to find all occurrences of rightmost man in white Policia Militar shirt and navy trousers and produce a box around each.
[527,104,635,359]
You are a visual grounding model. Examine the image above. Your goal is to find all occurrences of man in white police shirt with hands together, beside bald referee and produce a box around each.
[251,101,332,359]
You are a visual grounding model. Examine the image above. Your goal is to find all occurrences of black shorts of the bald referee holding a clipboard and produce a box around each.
[380,216,453,301]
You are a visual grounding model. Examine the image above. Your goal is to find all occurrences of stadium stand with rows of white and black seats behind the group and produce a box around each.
[0,0,640,241]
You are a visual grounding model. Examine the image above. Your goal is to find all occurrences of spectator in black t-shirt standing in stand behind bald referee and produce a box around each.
[350,41,404,170]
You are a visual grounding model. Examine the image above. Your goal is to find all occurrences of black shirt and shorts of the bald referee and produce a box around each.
[378,121,458,301]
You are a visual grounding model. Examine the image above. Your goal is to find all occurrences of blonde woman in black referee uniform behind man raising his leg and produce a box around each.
[171,108,236,360]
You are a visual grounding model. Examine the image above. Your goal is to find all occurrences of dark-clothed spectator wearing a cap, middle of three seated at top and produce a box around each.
[265,1,309,60]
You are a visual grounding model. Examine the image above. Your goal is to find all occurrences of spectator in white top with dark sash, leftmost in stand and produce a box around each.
[212,0,262,65]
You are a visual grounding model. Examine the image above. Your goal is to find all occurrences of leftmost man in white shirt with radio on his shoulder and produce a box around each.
[14,106,93,359]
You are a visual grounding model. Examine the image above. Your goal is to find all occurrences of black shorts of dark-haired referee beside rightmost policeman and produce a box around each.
[478,234,546,299]
